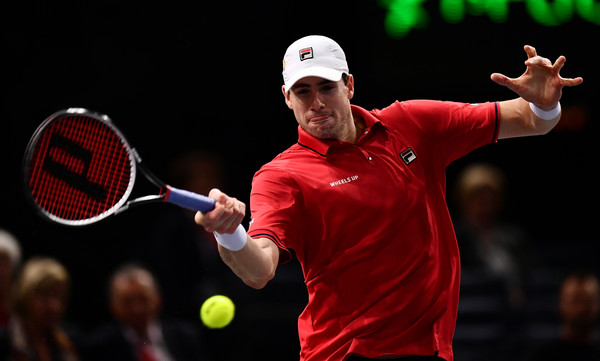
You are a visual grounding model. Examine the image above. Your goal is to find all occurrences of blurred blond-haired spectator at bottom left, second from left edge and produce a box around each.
[5,257,79,361]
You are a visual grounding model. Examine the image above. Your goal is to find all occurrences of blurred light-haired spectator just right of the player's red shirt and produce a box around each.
[454,163,528,308]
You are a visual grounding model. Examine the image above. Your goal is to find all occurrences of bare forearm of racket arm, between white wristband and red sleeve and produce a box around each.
[219,235,279,289]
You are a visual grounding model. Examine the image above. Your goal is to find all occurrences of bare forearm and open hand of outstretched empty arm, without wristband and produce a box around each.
[491,45,583,138]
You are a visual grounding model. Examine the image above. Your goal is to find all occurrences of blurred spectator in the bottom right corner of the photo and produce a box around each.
[532,272,600,361]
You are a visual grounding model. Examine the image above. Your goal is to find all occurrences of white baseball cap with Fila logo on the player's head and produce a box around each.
[283,35,349,92]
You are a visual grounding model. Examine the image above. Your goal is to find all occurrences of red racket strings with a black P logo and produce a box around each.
[30,115,133,220]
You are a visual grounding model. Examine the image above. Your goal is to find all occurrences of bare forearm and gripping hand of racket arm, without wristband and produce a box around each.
[195,189,279,288]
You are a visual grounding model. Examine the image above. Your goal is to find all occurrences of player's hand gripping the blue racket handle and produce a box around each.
[194,188,246,234]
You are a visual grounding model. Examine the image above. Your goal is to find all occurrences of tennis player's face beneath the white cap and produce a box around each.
[284,76,354,142]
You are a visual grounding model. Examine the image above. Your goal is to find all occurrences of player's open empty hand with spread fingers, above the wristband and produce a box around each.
[491,45,583,110]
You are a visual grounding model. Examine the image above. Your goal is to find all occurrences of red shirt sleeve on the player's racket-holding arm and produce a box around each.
[248,165,302,264]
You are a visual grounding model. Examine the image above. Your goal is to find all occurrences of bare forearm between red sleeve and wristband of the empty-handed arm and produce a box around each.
[498,98,560,139]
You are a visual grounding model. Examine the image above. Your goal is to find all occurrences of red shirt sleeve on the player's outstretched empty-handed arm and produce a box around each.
[380,100,500,165]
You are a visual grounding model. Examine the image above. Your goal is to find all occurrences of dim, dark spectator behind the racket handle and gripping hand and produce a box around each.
[130,151,231,320]
